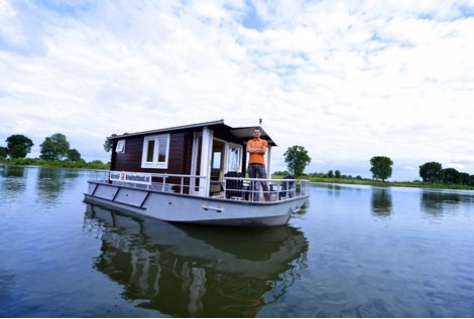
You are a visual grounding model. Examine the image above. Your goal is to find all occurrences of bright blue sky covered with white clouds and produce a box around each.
[0,0,474,181]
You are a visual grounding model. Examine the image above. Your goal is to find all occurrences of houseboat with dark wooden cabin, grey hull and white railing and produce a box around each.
[84,120,309,227]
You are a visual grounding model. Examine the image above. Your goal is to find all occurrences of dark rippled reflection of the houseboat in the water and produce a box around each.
[85,204,308,317]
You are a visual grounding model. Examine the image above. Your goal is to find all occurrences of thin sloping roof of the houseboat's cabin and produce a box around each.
[107,119,276,146]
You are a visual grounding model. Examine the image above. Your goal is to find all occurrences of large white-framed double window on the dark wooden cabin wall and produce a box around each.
[142,134,170,169]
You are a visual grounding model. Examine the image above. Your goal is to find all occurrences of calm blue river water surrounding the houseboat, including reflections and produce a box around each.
[0,166,474,317]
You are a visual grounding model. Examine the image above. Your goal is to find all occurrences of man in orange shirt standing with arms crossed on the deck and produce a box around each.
[247,128,270,201]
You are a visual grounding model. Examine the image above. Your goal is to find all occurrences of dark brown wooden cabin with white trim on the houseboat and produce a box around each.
[108,120,276,196]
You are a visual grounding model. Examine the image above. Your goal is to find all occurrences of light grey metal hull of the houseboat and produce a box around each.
[84,181,309,227]
